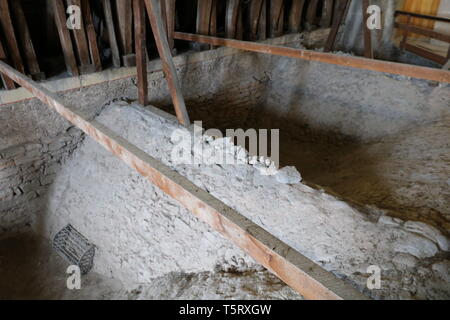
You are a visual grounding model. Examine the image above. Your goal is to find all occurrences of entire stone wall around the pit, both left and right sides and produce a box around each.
[0,30,450,234]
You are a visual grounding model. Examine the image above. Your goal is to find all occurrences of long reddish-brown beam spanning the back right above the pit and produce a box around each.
[175,32,450,83]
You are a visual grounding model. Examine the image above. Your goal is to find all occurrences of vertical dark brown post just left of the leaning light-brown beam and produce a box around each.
[133,0,148,106]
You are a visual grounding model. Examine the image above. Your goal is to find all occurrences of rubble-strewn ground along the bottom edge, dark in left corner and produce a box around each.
[0,233,300,300]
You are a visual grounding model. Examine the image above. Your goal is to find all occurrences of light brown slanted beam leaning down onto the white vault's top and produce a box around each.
[145,0,190,126]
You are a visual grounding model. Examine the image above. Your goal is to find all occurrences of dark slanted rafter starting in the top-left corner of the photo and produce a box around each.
[0,0,25,73]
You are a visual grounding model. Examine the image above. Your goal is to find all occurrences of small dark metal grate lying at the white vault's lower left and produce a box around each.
[53,224,95,274]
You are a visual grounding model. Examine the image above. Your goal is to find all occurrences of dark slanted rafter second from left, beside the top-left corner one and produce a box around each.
[11,0,45,80]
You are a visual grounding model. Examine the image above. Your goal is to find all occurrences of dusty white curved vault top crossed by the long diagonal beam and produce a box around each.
[38,104,450,298]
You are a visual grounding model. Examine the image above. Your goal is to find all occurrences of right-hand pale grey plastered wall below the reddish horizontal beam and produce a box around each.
[247,57,450,141]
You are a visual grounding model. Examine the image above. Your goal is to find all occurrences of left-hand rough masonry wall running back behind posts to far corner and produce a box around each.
[0,51,266,236]
